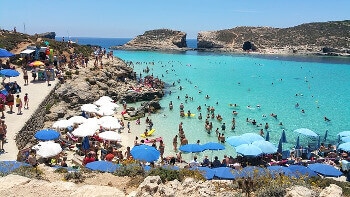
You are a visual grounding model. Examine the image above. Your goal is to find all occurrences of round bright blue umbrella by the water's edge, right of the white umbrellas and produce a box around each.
[130,144,160,162]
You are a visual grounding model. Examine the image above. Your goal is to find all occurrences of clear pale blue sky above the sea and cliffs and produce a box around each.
[0,0,350,38]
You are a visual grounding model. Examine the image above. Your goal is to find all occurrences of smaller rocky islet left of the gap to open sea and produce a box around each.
[111,29,187,50]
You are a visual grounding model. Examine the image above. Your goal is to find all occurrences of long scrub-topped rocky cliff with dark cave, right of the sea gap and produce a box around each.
[197,20,350,54]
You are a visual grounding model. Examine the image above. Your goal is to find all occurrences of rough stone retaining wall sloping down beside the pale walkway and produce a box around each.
[15,83,60,150]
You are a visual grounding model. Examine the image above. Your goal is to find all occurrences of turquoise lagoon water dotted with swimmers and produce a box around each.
[114,48,350,159]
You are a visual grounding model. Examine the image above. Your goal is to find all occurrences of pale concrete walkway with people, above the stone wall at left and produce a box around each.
[0,69,58,161]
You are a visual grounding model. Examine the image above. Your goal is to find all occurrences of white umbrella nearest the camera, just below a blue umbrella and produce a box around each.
[32,141,62,158]
